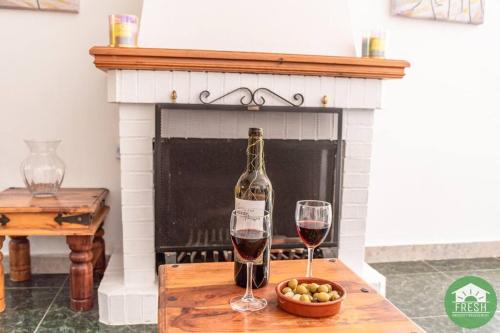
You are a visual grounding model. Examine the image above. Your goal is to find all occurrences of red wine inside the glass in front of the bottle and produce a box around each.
[231,229,268,261]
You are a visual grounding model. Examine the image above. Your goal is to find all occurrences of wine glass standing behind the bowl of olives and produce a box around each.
[295,200,332,277]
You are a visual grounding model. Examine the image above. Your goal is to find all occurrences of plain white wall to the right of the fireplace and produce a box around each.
[351,0,500,246]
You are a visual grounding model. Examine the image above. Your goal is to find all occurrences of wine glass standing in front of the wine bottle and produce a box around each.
[229,209,271,312]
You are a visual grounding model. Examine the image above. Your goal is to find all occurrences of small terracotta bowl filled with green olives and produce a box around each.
[276,277,346,318]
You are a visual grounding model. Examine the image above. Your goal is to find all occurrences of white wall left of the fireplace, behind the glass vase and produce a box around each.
[0,0,141,254]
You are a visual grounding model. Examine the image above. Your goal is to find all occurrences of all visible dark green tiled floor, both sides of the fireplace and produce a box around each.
[4,258,500,333]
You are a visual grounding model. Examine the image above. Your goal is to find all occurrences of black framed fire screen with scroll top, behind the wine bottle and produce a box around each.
[154,98,343,265]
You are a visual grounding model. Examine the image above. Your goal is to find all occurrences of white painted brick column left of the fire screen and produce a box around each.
[120,104,156,286]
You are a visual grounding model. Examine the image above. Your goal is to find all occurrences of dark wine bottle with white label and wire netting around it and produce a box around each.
[233,128,274,288]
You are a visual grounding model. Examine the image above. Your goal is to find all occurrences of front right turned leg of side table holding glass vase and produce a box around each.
[66,236,94,311]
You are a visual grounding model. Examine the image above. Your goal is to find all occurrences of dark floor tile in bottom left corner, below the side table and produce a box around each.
[0,288,57,333]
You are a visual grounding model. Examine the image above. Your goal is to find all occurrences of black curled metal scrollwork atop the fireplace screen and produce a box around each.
[200,87,304,107]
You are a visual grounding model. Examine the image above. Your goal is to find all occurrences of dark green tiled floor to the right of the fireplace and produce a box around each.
[371,258,500,333]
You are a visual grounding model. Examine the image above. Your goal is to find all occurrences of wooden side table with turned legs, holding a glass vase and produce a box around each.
[0,188,109,312]
